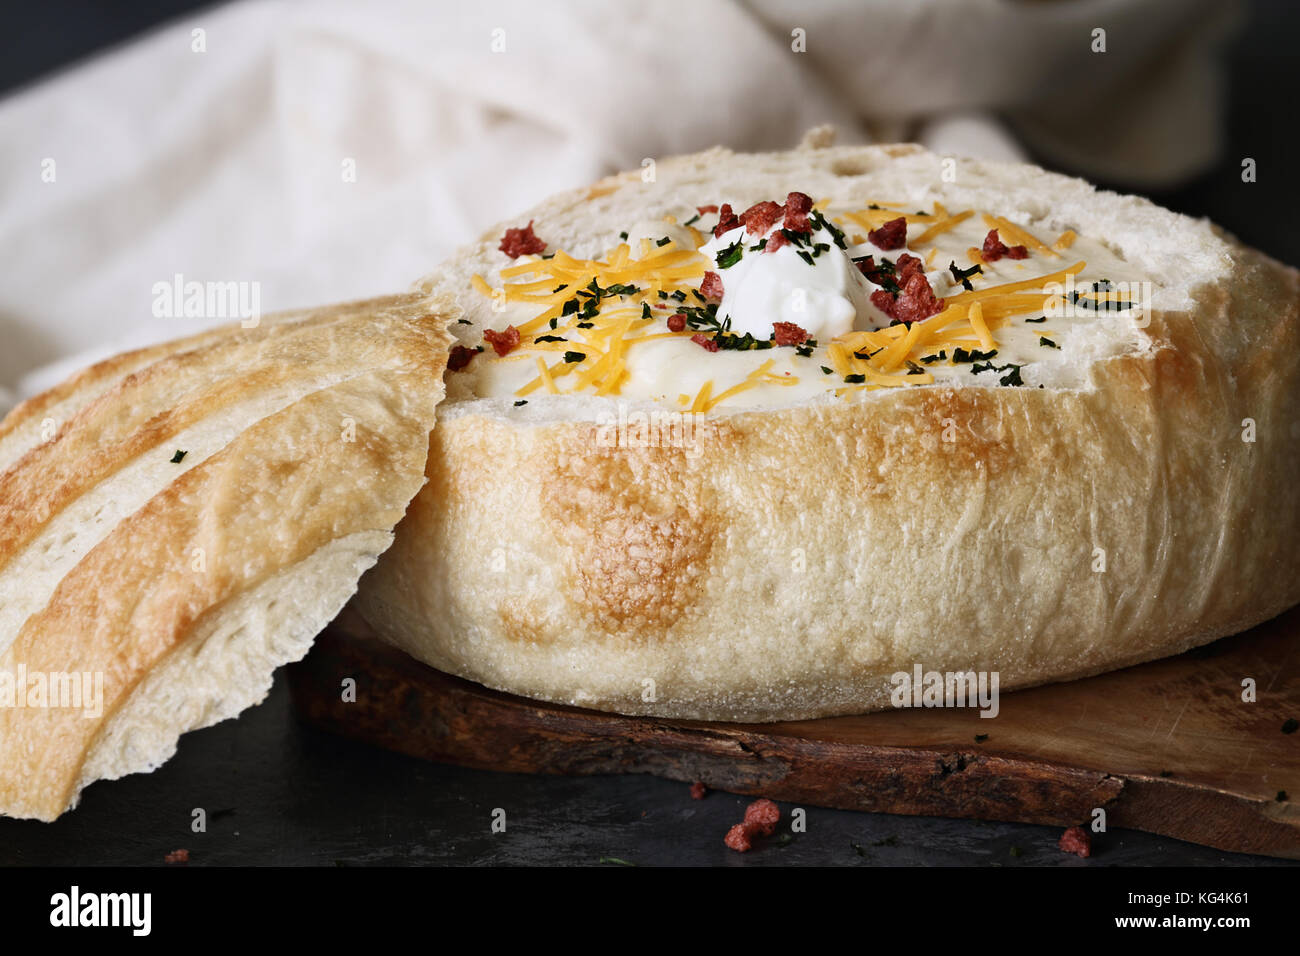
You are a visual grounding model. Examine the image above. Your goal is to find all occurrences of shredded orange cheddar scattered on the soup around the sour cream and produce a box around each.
[469,199,1122,414]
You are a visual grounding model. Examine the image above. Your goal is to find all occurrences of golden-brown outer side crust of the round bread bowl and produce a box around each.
[359,170,1300,721]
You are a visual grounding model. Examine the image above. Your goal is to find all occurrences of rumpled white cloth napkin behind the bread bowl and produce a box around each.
[0,0,1231,411]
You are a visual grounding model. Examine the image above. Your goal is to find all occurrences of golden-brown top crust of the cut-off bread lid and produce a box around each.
[0,295,450,819]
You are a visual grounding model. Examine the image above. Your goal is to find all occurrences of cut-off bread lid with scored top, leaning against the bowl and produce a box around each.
[0,294,450,821]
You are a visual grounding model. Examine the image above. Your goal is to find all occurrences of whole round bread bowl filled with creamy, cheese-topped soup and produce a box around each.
[358,143,1300,722]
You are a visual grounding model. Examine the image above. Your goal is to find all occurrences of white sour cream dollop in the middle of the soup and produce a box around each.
[699,220,889,342]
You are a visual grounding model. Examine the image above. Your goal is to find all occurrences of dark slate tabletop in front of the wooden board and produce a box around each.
[0,674,1300,866]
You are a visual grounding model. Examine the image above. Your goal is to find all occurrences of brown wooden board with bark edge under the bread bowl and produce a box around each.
[289,609,1300,858]
